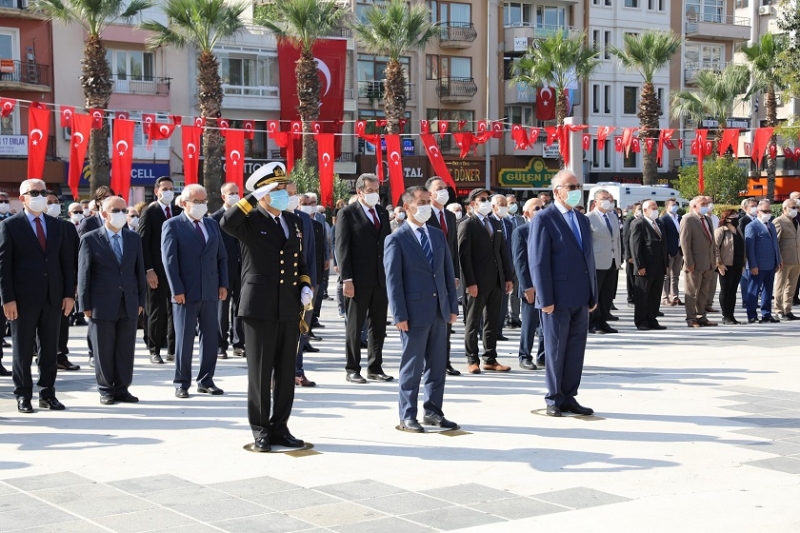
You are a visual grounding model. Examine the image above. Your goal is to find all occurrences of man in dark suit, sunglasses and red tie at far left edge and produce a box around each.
[0,179,75,413]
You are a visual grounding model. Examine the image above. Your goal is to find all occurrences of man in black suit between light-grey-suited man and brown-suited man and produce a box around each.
[630,200,672,330]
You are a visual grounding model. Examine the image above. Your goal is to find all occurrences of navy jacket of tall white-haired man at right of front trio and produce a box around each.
[528,203,597,309]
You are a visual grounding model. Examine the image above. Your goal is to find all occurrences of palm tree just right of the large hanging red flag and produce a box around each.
[352,0,440,134]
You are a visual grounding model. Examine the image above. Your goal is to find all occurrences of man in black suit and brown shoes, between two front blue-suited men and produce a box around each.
[458,189,514,374]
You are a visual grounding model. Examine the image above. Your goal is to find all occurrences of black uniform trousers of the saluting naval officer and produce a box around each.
[242,317,299,438]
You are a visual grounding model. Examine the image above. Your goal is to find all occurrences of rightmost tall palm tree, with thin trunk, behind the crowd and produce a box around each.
[739,33,788,199]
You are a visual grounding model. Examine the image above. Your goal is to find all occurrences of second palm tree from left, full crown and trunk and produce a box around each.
[140,0,248,209]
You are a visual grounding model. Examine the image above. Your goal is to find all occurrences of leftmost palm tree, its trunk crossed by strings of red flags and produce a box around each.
[31,0,152,191]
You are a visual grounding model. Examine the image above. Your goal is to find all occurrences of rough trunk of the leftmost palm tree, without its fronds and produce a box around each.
[80,36,112,196]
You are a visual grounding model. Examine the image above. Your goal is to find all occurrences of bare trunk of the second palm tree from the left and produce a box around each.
[197,50,222,212]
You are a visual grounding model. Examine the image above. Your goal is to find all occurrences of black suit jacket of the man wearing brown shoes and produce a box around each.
[458,215,512,292]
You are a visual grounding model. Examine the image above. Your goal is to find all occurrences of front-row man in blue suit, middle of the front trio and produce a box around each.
[383,187,458,433]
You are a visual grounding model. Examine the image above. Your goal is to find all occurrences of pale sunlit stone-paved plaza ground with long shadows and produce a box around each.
[0,280,800,533]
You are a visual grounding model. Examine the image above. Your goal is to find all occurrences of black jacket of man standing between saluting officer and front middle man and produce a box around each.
[336,202,391,294]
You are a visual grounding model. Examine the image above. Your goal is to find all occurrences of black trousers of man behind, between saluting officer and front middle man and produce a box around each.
[345,284,389,374]
